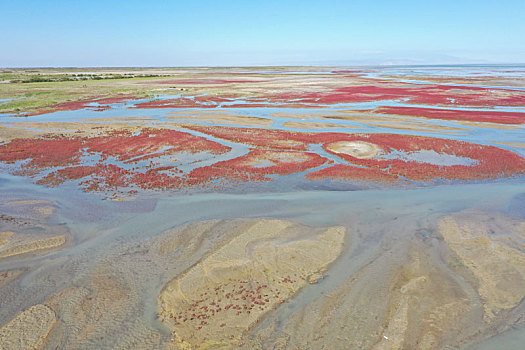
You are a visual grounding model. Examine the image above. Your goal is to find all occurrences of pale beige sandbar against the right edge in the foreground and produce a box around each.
[439,217,525,321]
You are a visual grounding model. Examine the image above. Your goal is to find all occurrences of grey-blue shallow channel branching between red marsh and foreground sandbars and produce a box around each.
[0,170,525,349]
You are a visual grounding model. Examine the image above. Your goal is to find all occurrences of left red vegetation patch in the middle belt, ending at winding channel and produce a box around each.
[0,129,231,190]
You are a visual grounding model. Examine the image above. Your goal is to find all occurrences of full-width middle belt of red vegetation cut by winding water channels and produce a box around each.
[0,125,525,191]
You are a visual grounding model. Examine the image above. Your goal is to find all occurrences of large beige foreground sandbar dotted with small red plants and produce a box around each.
[159,220,345,348]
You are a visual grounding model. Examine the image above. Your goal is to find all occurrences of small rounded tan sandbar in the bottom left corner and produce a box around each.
[0,304,57,350]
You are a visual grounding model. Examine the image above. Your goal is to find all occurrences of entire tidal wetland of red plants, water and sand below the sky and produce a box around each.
[0,66,525,349]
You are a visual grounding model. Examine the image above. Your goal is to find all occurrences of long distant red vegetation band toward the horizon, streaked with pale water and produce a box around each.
[131,79,525,108]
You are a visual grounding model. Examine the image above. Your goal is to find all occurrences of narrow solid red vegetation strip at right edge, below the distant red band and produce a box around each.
[376,107,525,124]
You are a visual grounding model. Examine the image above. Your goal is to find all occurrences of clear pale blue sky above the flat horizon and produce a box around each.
[0,0,525,67]
